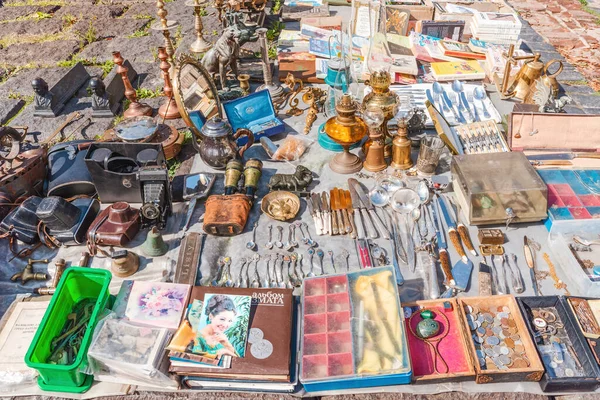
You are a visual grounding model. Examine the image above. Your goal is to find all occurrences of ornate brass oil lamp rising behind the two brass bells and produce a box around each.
[362,71,400,157]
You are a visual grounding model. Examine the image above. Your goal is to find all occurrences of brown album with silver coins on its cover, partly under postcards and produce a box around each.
[171,286,294,381]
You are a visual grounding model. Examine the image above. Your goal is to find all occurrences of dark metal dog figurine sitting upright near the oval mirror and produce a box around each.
[202,27,240,90]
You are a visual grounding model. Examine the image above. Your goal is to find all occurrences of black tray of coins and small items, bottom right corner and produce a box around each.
[517,296,600,392]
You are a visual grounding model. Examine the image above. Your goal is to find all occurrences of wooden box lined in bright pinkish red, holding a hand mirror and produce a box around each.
[402,299,475,384]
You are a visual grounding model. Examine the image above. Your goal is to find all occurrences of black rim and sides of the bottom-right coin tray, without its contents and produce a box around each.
[517,296,600,392]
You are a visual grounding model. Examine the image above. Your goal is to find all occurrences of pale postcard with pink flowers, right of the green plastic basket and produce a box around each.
[125,281,190,329]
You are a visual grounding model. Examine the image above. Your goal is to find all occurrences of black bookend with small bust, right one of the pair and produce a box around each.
[90,60,137,118]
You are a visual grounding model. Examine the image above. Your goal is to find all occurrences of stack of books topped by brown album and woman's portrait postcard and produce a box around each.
[167,286,297,391]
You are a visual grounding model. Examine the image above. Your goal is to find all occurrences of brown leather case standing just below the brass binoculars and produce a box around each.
[204,194,252,236]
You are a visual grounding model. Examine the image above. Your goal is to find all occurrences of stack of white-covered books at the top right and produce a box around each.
[471,11,521,44]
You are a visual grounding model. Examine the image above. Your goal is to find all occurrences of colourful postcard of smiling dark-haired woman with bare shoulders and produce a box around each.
[191,293,252,357]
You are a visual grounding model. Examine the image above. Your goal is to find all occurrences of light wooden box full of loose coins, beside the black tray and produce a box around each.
[458,295,544,383]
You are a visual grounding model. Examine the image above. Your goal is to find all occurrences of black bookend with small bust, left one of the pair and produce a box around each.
[31,63,90,118]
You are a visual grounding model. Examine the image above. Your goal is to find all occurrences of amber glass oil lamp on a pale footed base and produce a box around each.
[323,94,367,174]
